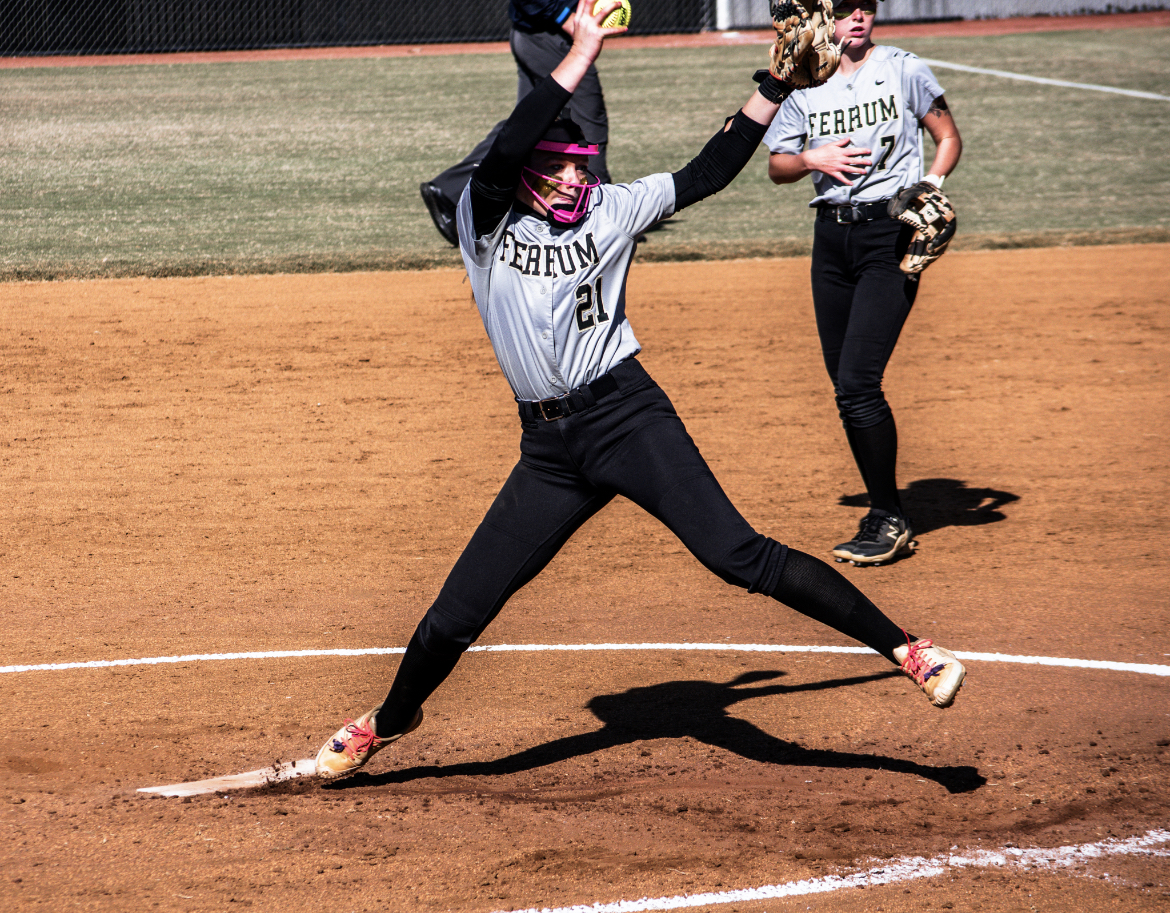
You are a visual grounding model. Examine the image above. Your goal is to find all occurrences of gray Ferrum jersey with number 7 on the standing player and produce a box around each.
[764,44,943,206]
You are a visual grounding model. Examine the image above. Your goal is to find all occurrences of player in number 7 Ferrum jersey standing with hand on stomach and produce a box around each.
[764,0,963,564]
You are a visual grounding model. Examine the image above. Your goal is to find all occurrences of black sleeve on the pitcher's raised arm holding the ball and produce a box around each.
[470,76,572,238]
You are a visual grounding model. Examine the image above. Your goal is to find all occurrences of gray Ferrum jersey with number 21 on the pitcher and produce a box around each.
[456,173,674,401]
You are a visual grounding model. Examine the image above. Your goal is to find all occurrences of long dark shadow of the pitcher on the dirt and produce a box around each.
[348,671,986,792]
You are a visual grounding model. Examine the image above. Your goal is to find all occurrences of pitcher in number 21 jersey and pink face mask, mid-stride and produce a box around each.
[317,0,965,777]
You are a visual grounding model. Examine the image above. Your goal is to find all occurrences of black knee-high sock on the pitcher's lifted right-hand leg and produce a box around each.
[770,548,907,663]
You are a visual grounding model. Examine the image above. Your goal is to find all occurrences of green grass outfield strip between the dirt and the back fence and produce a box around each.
[0,28,1170,280]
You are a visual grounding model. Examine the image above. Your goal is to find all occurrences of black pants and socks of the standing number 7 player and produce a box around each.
[812,204,918,516]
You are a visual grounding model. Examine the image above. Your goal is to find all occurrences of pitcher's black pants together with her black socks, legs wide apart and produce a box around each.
[377,358,907,736]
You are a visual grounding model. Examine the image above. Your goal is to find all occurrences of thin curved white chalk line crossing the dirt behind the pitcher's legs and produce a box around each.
[0,644,1170,677]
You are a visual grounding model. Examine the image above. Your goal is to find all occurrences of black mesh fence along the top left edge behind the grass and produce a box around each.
[0,0,716,56]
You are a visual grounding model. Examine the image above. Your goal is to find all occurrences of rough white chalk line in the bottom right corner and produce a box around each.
[500,830,1170,913]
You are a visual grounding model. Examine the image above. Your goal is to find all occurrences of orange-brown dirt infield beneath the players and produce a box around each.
[0,245,1170,913]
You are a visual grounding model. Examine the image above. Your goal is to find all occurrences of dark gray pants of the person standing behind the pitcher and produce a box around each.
[431,28,610,201]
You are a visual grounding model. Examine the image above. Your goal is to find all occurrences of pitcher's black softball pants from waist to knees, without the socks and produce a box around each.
[422,359,784,652]
